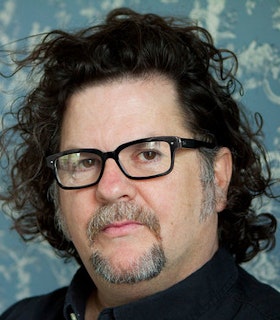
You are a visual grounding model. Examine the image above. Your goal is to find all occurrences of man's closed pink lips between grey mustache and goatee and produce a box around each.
[101,221,143,237]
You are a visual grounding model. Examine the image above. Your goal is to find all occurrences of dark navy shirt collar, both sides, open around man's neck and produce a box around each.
[64,249,238,320]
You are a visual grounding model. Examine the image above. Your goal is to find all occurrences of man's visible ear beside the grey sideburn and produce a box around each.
[214,147,232,212]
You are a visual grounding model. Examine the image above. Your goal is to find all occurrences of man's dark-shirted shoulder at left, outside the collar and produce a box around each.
[0,287,67,320]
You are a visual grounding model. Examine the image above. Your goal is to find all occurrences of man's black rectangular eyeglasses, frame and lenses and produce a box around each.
[47,136,216,189]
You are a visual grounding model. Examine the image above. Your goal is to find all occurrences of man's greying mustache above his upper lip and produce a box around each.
[87,202,161,243]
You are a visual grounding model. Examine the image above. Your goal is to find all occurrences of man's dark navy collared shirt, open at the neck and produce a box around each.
[0,249,280,320]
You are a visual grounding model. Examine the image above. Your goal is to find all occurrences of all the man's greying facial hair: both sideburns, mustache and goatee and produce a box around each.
[49,154,223,284]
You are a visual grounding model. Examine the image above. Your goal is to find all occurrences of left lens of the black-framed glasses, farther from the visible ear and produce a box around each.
[55,152,102,187]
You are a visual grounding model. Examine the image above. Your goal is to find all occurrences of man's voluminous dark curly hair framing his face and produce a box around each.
[0,8,278,263]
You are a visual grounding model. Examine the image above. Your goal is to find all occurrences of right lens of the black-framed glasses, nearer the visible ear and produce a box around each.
[119,141,171,178]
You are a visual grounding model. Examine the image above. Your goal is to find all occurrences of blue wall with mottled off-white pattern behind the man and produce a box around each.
[0,0,280,314]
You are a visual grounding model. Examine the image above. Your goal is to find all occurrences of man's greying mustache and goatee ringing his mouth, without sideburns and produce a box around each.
[87,202,166,284]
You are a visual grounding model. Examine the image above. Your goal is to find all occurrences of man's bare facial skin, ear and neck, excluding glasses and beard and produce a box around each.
[59,75,231,316]
